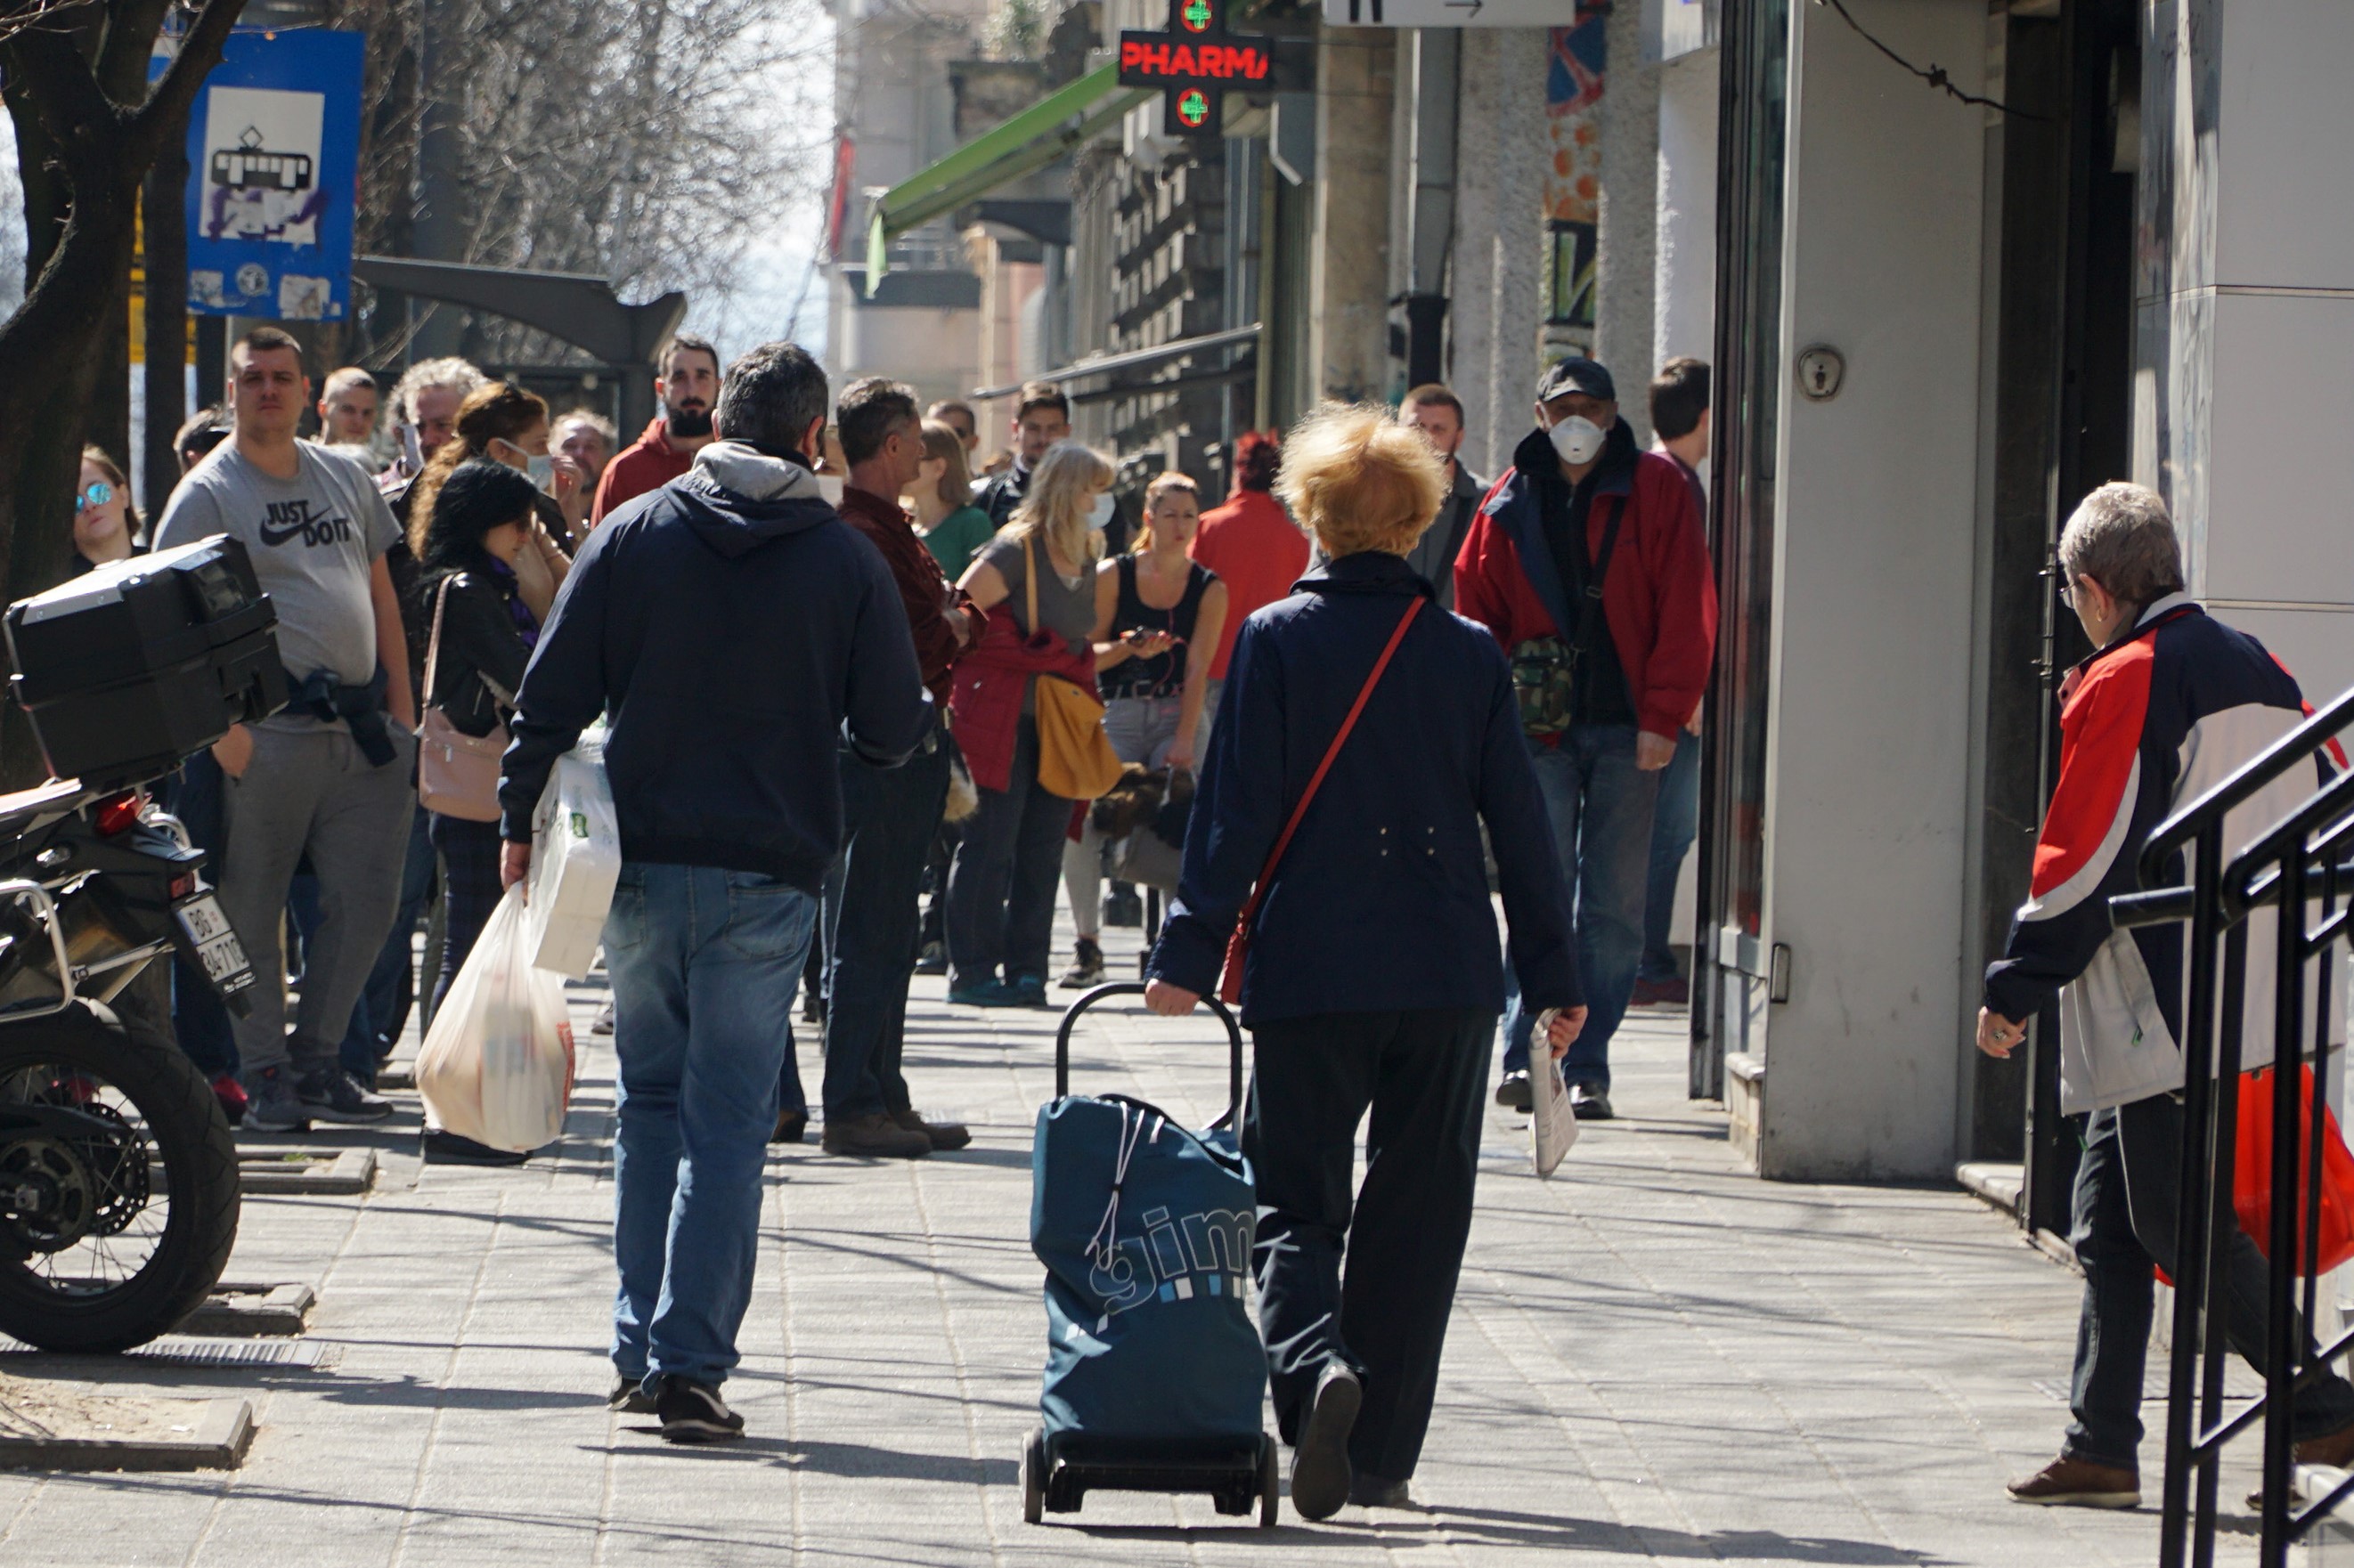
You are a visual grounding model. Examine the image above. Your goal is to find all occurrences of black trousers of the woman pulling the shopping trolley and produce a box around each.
[1243,1008,1495,1481]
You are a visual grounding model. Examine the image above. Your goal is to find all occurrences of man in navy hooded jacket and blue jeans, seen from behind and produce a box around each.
[499,344,933,1443]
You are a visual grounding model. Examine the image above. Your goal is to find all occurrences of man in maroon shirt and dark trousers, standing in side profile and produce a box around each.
[824,377,982,1158]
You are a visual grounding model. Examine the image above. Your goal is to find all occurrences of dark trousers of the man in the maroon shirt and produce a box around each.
[824,730,949,1123]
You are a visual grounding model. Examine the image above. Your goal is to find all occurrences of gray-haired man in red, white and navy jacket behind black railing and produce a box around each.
[1977,485,2354,1509]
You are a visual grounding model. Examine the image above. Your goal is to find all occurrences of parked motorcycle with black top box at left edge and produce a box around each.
[0,537,287,1352]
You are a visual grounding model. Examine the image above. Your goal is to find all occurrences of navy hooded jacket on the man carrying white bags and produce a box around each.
[499,443,933,892]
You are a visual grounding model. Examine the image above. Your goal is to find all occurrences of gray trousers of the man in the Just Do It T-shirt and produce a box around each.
[221,725,417,1078]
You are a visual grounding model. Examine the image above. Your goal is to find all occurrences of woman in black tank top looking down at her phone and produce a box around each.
[1062,471,1226,991]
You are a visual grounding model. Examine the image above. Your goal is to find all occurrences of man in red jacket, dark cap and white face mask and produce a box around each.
[1454,358,1716,1121]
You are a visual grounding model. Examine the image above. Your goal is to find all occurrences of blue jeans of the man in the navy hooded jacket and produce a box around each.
[605,862,817,1392]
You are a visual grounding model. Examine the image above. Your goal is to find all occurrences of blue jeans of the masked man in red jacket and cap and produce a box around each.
[1504,725,1659,1090]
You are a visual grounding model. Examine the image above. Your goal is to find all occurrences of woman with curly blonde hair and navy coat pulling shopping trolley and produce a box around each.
[1146,405,1584,1518]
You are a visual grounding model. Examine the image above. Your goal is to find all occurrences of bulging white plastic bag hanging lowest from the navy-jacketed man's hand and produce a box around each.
[417,888,572,1154]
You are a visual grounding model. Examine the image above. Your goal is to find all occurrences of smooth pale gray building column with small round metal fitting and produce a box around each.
[1728,0,1987,1180]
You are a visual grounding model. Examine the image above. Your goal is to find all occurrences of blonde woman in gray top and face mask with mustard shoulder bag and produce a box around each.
[946,443,1113,1008]
